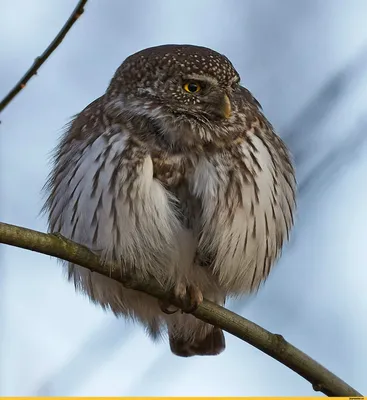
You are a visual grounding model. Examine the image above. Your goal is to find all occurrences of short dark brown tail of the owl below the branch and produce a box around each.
[168,321,226,357]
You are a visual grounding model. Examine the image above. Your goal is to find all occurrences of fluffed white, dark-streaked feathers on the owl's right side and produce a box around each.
[193,114,295,294]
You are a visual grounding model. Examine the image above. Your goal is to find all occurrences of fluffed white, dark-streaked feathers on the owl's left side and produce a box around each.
[45,98,183,279]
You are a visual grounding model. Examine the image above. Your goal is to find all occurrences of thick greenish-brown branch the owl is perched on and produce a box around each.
[0,222,362,397]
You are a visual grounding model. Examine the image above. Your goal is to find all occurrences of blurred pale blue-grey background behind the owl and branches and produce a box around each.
[0,0,367,396]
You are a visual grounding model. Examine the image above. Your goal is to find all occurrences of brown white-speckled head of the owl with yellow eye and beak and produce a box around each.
[107,45,244,133]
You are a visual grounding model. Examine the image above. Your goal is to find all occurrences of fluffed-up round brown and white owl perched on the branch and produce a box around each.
[44,45,296,357]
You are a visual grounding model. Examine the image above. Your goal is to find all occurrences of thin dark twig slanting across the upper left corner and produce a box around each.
[0,0,88,113]
